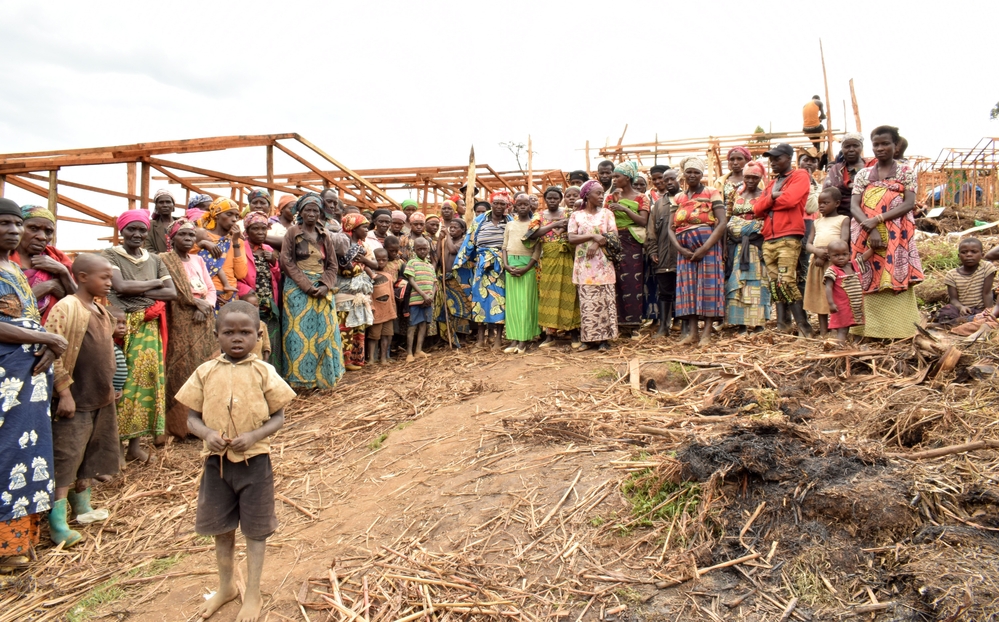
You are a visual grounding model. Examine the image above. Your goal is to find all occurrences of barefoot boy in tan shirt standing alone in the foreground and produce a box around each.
[177,300,295,622]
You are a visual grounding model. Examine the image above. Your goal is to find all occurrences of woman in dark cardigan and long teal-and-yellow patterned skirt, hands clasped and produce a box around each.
[280,192,344,389]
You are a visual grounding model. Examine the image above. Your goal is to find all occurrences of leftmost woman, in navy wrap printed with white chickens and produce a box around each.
[0,198,73,564]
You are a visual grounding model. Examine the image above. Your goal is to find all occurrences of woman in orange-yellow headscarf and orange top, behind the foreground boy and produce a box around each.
[197,197,246,309]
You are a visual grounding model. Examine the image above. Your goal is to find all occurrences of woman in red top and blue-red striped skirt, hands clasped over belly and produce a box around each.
[669,157,725,346]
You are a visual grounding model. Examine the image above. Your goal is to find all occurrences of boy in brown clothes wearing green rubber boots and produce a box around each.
[45,254,119,547]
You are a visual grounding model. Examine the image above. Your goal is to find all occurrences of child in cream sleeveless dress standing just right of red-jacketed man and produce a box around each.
[804,188,850,338]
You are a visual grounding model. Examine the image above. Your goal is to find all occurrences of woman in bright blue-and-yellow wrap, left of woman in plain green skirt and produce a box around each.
[453,190,510,350]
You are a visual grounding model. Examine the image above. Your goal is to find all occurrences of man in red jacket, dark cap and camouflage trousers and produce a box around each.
[753,143,812,337]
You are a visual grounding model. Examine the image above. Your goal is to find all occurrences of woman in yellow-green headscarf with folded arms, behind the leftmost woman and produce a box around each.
[10,205,76,324]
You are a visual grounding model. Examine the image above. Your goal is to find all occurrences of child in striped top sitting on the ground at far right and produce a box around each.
[936,238,996,325]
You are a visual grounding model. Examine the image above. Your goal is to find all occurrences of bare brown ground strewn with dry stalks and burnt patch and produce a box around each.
[0,336,999,622]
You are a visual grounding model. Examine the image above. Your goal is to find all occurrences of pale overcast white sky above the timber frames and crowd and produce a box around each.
[0,0,999,247]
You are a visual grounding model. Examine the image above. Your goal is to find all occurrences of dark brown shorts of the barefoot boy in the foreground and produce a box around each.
[194,454,277,540]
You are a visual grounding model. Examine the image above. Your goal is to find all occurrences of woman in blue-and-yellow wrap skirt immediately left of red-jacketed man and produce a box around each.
[725,162,770,334]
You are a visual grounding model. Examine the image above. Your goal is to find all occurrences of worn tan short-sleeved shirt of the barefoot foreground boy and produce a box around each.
[176,354,295,462]
